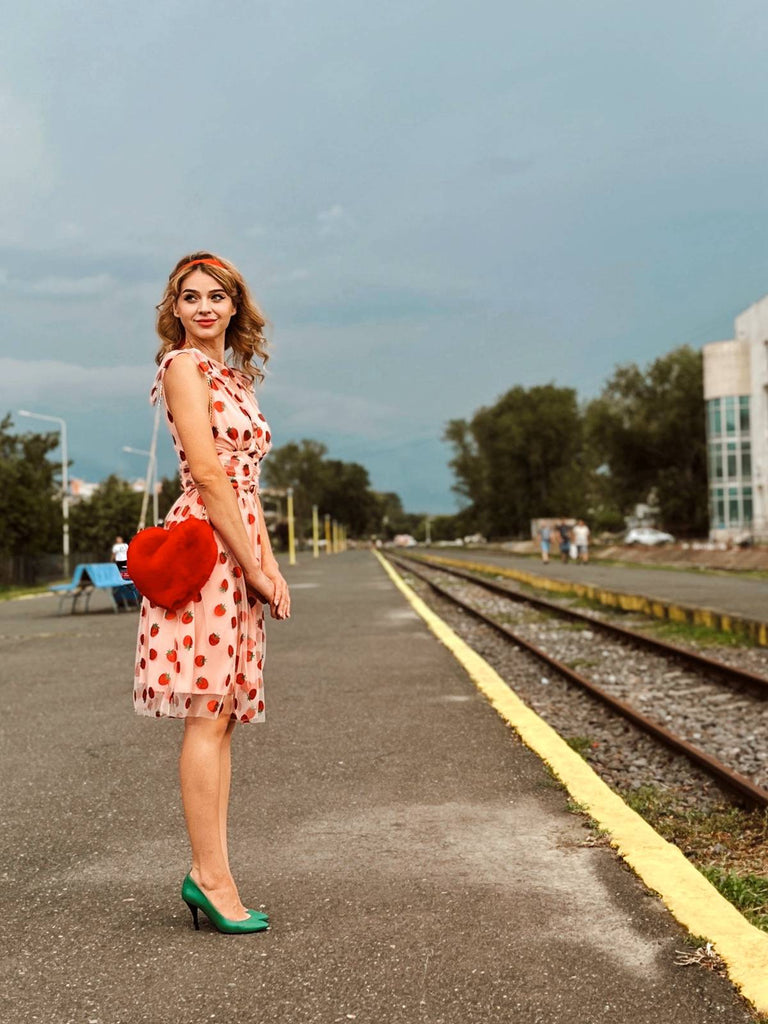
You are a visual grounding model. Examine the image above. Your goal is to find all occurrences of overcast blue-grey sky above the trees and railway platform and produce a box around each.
[0,0,768,513]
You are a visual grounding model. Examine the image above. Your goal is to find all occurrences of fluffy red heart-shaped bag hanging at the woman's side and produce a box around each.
[128,518,218,611]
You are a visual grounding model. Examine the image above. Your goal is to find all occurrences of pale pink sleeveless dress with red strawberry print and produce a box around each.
[133,348,271,722]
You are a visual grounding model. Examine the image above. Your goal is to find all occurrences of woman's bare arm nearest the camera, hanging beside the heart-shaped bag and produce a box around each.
[163,356,274,600]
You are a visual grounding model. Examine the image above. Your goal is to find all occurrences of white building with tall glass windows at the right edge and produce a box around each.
[703,296,768,541]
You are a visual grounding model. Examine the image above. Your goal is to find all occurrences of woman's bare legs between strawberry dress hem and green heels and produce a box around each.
[179,715,247,921]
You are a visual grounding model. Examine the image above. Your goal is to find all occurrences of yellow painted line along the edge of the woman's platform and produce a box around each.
[374,551,768,1013]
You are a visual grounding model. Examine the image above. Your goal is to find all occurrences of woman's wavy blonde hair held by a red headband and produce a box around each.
[155,252,269,381]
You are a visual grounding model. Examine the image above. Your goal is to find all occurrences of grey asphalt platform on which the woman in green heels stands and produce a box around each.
[0,551,768,1024]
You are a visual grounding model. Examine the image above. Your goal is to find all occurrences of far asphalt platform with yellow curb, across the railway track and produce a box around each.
[421,548,768,646]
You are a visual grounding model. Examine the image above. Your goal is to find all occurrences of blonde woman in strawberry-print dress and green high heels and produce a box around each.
[133,252,291,933]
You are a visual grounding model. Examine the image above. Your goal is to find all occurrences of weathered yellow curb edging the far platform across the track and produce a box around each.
[415,555,768,647]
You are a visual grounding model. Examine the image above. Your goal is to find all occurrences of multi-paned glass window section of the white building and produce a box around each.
[707,394,753,530]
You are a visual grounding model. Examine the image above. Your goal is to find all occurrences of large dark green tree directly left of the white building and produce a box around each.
[586,345,709,536]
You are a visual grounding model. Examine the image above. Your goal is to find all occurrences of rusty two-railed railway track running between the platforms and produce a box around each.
[388,555,768,808]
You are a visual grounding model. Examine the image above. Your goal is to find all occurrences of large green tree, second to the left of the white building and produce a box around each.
[444,384,586,538]
